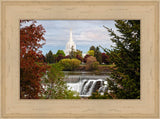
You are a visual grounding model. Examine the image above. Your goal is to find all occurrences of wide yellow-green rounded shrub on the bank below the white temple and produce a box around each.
[59,59,81,71]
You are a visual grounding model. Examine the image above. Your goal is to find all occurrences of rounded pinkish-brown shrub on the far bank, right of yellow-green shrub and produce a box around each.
[86,56,99,70]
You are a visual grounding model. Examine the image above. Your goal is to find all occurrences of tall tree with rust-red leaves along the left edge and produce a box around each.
[20,20,48,99]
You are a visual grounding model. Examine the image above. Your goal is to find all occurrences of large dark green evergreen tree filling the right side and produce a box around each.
[105,20,140,99]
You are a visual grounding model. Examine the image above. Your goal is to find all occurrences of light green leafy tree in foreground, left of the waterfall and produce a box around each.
[42,63,79,99]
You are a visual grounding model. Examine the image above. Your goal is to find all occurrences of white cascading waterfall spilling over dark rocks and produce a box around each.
[67,79,107,97]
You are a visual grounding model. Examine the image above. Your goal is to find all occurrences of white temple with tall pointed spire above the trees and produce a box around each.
[65,30,76,55]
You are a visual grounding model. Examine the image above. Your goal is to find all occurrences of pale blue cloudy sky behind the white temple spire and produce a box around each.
[22,20,116,55]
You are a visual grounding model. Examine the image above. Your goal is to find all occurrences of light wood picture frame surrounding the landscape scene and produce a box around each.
[0,0,160,119]
